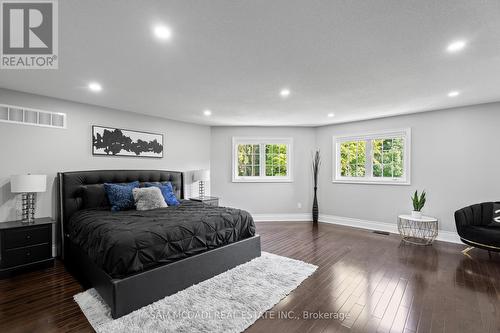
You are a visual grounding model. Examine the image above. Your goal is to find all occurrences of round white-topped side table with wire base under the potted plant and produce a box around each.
[398,215,438,245]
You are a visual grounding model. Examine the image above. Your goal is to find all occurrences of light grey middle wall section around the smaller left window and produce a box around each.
[210,127,315,214]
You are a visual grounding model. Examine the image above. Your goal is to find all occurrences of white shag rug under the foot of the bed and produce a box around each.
[74,252,317,333]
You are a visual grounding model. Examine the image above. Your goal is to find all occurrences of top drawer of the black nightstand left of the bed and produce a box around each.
[4,225,52,249]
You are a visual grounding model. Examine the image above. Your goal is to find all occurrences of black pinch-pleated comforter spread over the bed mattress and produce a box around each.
[68,200,255,278]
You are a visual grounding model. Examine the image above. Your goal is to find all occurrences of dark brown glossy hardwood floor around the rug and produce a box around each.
[0,222,500,333]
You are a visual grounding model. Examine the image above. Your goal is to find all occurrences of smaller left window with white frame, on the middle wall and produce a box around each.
[233,137,292,182]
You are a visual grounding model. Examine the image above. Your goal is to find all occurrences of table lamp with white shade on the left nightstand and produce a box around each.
[10,174,47,223]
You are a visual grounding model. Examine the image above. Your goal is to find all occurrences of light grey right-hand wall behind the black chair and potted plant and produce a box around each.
[316,103,500,231]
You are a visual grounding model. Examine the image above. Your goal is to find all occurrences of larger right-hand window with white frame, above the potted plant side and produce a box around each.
[333,129,411,185]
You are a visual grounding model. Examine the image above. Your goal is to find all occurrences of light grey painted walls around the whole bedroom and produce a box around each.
[0,85,500,235]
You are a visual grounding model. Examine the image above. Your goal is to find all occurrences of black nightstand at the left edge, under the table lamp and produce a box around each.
[0,217,55,278]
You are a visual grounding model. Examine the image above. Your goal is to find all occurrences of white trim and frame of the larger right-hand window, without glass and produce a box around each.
[332,128,411,185]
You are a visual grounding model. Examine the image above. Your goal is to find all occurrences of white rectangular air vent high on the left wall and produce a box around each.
[0,104,66,128]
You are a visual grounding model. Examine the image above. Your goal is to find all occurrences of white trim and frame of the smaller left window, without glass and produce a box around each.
[231,137,293,183]
